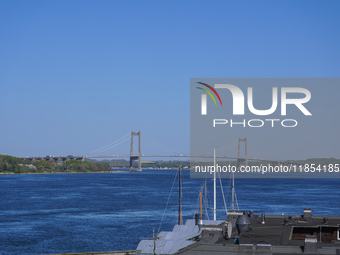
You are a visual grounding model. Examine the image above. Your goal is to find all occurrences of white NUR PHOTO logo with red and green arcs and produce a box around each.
[196,82,312,127]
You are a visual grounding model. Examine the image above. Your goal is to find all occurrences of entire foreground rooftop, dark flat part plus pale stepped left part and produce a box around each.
[136,209,340,255]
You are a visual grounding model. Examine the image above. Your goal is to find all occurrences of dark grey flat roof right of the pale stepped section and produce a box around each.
[176,209,340,255]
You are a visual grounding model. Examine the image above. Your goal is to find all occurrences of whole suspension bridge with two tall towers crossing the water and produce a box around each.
[21,131,300,171]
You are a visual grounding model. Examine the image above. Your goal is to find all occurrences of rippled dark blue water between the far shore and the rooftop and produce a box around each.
[0,170,340,254]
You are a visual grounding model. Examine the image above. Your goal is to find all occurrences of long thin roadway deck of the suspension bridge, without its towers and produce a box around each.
[21,154,303,164]
